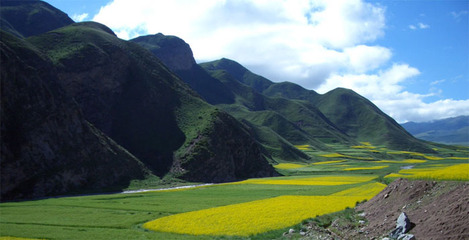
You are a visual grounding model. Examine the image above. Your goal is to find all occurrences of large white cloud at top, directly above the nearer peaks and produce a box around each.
[94,0,391,87]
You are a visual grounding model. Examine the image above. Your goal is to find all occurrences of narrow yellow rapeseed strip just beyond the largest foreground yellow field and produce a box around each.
[235,176,376,186]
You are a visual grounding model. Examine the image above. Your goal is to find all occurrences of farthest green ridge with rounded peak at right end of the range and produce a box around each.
[201,59,433,152]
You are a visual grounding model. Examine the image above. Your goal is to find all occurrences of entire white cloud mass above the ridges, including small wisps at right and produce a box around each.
[93,0,469,122]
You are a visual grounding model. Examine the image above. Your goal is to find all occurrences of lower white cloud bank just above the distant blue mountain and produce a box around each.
[318,64,469,123]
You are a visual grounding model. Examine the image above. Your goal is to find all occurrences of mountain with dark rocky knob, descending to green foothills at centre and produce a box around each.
[132,34,355,161]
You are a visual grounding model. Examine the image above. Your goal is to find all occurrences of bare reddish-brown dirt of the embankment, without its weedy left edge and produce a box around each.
[357,179,469,240]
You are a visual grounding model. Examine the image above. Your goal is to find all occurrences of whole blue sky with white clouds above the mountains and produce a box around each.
[46,0,469,123]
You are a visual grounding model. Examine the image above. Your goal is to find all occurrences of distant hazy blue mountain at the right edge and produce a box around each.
[402,116,469,146]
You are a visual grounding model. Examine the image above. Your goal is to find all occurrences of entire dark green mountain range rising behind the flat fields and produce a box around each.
[0,0,434,201]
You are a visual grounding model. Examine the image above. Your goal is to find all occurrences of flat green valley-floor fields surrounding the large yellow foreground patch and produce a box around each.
[0,144,469,239]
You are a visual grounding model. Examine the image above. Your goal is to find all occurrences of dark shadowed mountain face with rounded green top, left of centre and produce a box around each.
[29,23,185,176]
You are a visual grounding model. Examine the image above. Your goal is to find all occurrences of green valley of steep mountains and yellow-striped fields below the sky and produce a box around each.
[0,0,469,240]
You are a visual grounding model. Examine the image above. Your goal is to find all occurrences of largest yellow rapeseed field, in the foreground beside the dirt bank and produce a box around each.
[143,196,372,236]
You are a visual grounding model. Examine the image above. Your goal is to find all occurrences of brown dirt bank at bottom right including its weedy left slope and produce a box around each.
[283,179,469,240]
